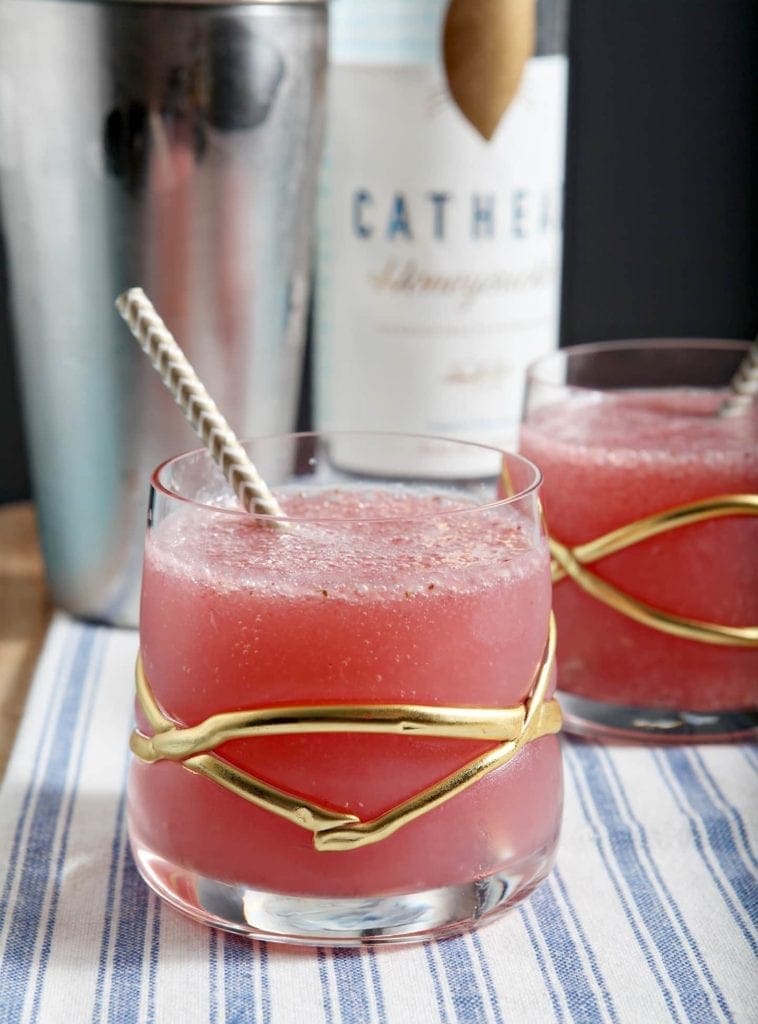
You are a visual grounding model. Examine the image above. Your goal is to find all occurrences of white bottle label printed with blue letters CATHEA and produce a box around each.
[317,55,567,475]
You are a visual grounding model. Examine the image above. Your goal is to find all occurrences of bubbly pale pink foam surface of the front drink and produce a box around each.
[148,485,547,600]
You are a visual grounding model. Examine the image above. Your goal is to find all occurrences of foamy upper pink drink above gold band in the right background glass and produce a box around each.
[520,388,758,544]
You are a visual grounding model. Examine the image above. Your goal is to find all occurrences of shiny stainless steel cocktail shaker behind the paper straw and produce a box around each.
[0,0,327,624]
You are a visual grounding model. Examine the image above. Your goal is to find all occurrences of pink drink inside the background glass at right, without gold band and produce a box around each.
[520,346,758,734]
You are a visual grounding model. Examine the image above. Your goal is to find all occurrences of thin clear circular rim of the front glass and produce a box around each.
[150,430,543,525]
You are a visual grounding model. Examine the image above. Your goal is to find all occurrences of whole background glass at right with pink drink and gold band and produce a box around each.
[520,343,758,736]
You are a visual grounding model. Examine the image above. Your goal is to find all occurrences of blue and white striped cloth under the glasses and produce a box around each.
[0,615,758,1024]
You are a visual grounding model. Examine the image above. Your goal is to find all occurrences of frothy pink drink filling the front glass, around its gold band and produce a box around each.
[129,432,561,942]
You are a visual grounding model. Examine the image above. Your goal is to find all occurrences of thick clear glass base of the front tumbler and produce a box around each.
[132,844,554,946]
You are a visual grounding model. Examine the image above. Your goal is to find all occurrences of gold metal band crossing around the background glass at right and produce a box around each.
[550,495,758,647]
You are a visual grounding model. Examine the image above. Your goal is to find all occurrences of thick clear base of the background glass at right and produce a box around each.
[556,690,758,743]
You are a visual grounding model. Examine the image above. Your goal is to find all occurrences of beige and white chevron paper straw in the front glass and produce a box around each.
[116,288,284,526]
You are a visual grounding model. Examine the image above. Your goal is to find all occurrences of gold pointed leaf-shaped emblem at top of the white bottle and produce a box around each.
[443,0,536,141]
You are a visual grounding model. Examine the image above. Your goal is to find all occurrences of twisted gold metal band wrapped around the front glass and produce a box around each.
[130,615,561,851]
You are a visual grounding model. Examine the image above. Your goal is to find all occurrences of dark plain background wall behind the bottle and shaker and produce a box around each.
[0,0,758,501]
